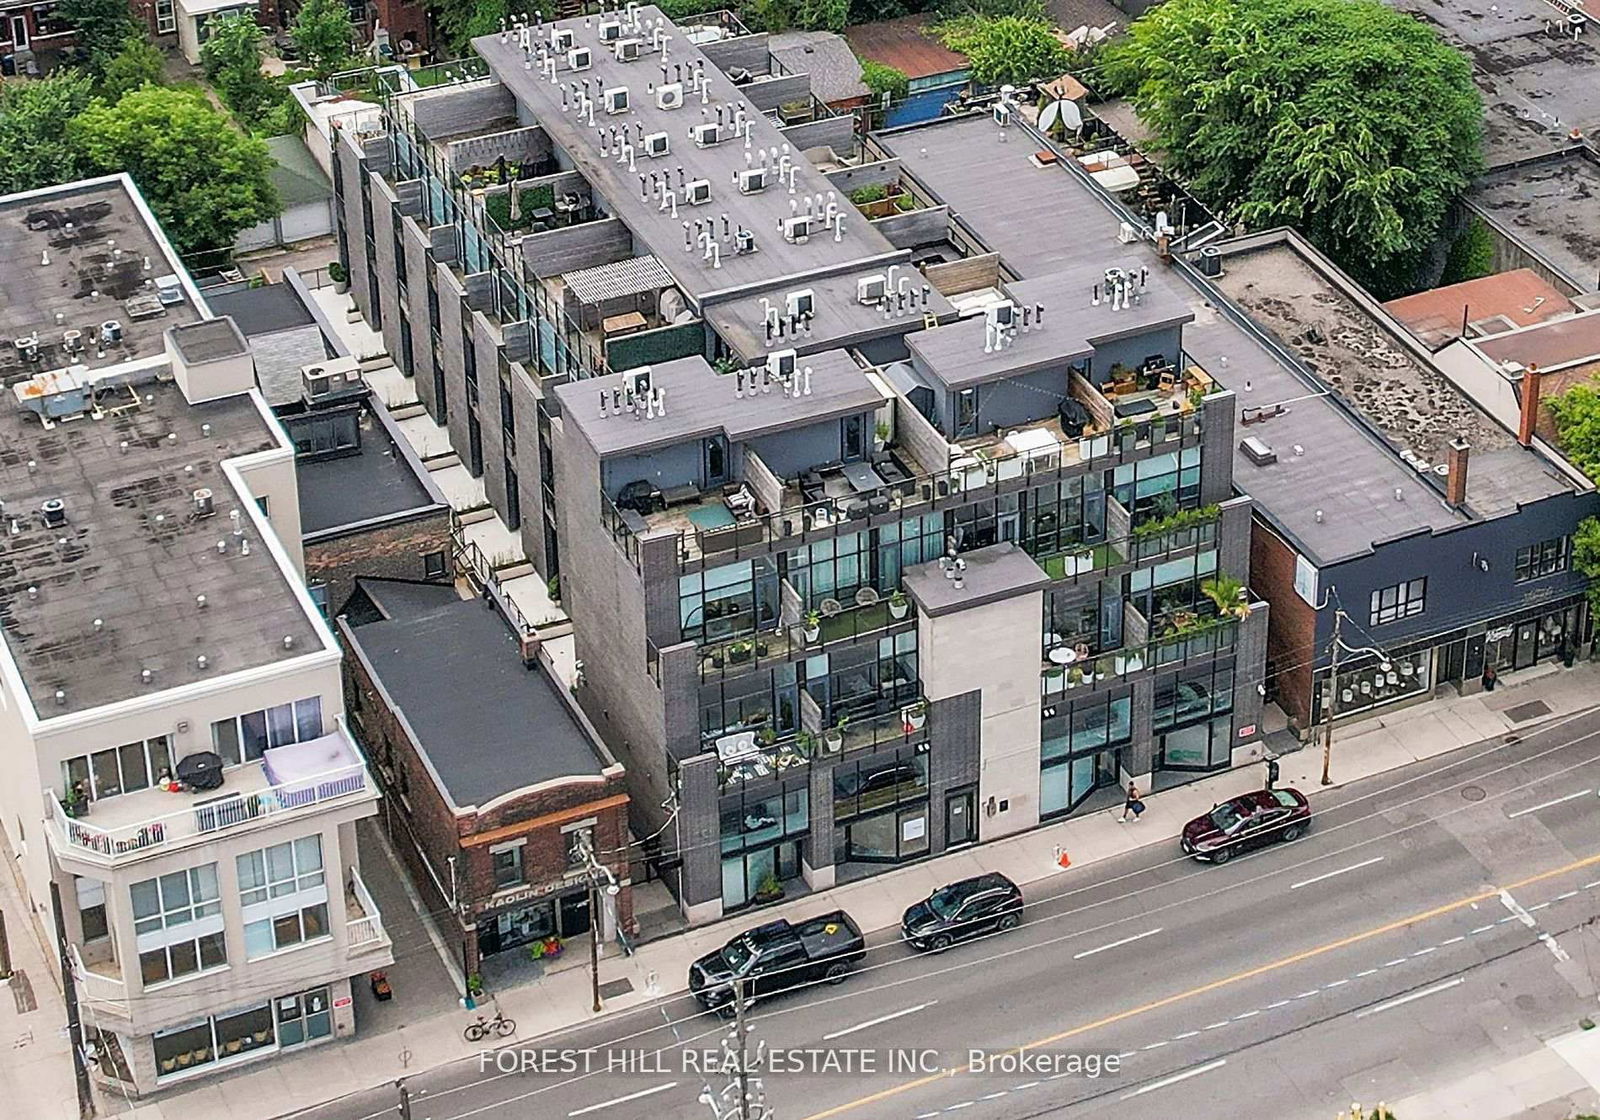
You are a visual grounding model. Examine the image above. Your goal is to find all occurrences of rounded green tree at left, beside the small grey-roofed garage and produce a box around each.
[67,86,278,254]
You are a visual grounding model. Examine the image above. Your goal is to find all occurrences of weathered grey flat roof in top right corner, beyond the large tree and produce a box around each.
[1389,0,1600,166]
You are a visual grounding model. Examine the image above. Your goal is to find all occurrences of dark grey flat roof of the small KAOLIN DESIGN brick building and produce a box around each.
[346,579,613,810]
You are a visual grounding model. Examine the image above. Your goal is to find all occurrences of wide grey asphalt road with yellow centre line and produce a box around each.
[302,714,1600,1120]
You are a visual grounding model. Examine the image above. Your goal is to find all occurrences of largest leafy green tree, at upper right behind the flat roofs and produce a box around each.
[1104,0,1483,294]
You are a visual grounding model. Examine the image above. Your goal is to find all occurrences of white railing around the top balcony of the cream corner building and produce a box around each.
[46,762,368,862]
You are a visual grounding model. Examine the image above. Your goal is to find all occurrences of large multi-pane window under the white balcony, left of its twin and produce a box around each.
[128,864,227,986]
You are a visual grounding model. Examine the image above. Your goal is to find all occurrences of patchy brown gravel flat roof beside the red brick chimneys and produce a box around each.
[1218,242,1571,517]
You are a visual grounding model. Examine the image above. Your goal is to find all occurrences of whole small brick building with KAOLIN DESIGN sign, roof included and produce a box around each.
[338,579,634,987]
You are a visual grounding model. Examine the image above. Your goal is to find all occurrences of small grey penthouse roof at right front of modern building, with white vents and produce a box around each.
[906,254,1194,387]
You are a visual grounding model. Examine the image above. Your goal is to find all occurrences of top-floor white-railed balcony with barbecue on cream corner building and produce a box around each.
[45,722,378,867]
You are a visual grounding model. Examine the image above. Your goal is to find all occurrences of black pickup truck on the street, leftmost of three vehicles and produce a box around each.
[690,910,867,1014]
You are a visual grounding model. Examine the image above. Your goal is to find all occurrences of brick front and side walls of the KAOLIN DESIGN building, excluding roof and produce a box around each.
[341,622,634,974]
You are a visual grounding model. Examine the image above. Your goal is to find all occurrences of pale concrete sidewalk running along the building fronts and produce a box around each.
[21,662,1600,1120]
